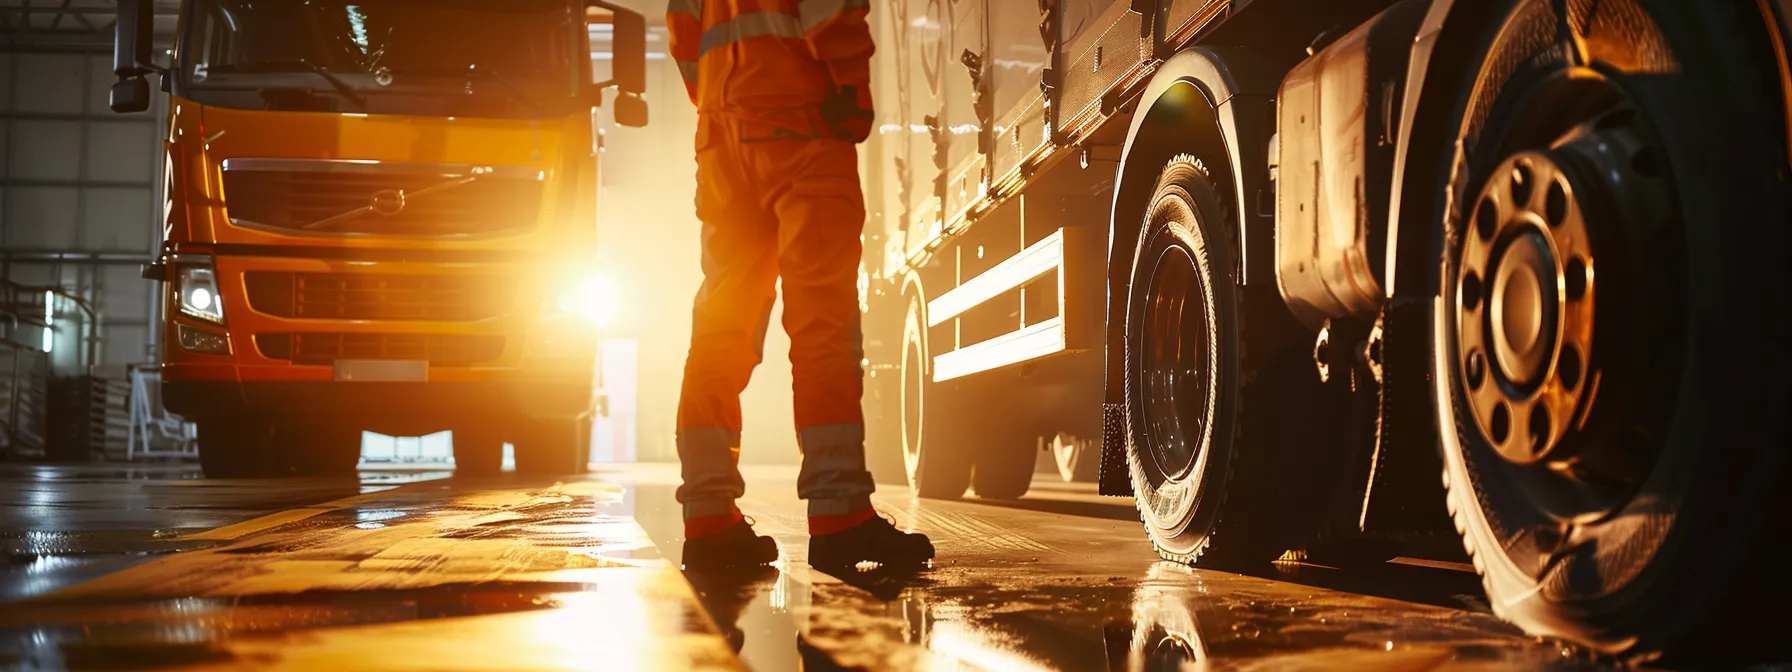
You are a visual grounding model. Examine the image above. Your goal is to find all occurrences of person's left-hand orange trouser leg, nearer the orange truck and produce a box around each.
[677,122,778,539]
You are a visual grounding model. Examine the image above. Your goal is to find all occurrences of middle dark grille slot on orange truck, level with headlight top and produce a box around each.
[244,271,514,323]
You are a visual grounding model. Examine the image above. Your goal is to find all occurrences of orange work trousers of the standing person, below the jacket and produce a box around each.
[677,116,874,516]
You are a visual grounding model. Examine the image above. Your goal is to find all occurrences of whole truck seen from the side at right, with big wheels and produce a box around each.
[862,0,1792,661]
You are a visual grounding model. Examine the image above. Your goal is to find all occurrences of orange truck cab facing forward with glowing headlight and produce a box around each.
[111,0,647,477]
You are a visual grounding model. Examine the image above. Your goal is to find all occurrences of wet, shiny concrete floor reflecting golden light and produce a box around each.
[0,464,1602,670]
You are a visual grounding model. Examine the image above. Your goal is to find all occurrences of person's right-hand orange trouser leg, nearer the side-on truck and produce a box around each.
[756,140,874,534]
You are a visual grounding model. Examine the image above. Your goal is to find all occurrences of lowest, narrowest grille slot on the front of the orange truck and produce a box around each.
[254,332,504,366]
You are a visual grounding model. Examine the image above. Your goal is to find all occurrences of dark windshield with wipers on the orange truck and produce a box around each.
[176,0,590,118]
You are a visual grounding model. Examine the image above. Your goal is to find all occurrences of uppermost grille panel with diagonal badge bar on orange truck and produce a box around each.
[224,159,545,238]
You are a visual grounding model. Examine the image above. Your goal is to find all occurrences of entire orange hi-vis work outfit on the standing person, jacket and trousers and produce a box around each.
[667,0,873,536]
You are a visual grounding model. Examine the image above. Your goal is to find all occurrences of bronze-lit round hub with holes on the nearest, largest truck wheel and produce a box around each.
[1455,151,1593,464]
